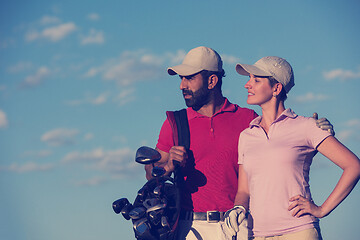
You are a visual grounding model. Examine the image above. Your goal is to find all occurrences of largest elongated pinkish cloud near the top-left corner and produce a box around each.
[25,22,76,42]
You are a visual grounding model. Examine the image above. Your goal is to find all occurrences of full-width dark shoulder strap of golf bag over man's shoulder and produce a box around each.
[166,109,190,149]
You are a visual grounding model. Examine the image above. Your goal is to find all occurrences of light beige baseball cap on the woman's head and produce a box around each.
[236,56,295,93]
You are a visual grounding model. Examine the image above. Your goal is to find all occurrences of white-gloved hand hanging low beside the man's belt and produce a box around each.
[224,205,246,236]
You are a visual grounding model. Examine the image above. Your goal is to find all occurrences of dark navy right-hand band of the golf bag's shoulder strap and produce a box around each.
[174,109,190,150]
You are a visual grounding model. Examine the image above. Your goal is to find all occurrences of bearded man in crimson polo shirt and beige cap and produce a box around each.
[145,46,334,239]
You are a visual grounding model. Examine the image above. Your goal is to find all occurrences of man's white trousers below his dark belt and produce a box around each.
[177,220,249,240]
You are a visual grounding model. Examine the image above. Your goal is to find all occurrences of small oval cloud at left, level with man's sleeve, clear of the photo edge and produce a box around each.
[41,128,79,146]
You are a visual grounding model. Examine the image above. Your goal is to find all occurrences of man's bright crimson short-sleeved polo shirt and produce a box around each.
[156,99,257,212]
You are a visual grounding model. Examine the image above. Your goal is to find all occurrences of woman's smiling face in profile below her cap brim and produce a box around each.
[245,74,274,106]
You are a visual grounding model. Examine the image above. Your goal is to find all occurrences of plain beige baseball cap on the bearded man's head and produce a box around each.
[167,46,222,76]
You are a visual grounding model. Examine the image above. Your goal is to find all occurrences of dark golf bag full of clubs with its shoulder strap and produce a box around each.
[113,109,190,240]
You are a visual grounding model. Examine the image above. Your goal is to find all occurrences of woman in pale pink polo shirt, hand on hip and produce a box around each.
[226,57,360,240]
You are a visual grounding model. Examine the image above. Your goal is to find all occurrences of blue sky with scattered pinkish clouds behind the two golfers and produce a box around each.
[0,0,360,240]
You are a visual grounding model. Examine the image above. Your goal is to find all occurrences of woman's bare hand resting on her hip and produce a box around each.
[288,195,325,218]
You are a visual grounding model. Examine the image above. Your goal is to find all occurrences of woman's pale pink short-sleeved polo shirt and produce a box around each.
[239,109,331,237]
